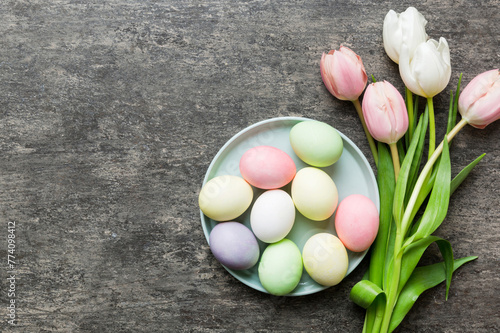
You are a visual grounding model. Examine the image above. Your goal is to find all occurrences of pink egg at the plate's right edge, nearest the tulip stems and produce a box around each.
[335,194,379,252]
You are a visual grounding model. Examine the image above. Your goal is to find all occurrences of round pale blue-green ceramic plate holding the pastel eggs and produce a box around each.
[200,117,380,296]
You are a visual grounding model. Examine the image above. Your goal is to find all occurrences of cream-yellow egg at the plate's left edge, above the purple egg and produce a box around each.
[198,175,253,221]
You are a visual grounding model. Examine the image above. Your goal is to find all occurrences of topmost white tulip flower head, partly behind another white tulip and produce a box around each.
[383,7,427,64]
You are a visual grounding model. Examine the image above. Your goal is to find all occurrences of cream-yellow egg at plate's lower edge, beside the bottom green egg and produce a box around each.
[302,233,349,286]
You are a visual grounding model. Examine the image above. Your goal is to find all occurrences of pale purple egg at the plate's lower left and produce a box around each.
[208,222,260,270]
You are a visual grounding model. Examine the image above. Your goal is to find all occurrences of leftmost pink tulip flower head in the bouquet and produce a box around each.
[320,46,368,101]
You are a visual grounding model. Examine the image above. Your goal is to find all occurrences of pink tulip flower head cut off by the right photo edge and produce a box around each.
[458,69,500,129]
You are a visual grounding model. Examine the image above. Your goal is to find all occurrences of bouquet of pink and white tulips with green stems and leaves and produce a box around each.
[320,7,500,332]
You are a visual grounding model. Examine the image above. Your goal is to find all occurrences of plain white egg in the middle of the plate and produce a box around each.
[250,190,295,243]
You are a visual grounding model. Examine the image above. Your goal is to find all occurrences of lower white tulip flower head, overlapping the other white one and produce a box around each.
[399,37,451,98]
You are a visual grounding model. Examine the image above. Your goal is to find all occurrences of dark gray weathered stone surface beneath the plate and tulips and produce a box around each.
[0,0,500,332]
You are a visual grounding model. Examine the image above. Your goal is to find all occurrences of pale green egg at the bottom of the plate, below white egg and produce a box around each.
[259,238,303,296]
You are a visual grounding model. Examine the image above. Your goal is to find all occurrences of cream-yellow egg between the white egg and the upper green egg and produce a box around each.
[292,167,338,221]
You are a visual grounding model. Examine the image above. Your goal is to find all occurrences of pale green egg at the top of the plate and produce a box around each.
[290,120,344,168]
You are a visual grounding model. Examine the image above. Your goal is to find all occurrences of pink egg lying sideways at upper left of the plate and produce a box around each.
[240,146,297,190]
